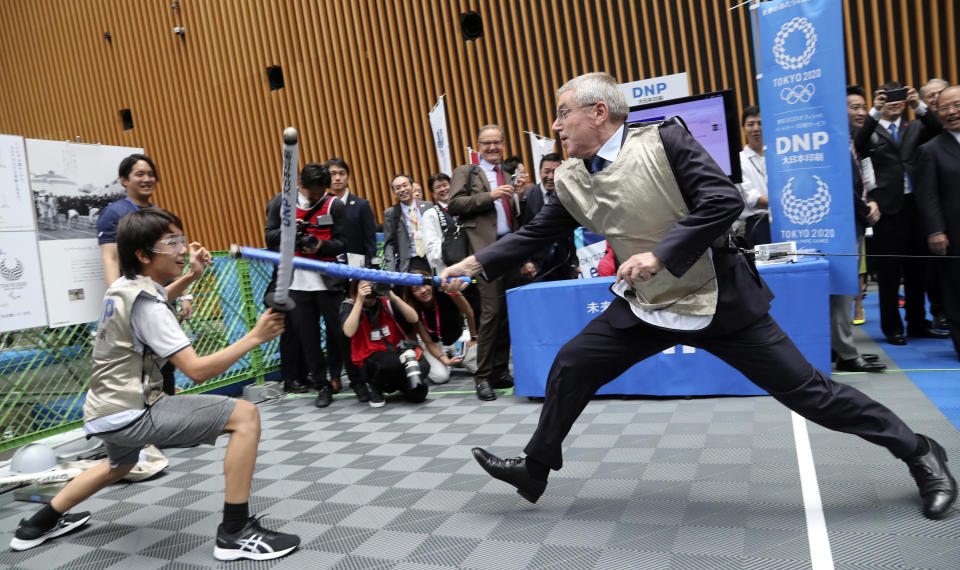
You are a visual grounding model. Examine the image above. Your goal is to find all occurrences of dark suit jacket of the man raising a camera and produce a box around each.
[853,110,943,214]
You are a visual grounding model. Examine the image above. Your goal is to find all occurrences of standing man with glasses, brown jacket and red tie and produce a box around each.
[447,125,526,401]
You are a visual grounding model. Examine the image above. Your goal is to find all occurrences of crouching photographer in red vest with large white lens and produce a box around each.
[340,280,430,408]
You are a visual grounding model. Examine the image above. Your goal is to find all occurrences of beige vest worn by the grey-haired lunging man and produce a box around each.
[555,125,717,315]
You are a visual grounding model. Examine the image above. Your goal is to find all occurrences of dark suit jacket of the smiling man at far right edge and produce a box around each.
[914,130,960,250]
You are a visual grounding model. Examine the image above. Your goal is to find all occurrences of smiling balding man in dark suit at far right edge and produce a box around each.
[916,86,960,356]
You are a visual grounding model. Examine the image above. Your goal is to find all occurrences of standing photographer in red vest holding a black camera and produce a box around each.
[264,162,345,408]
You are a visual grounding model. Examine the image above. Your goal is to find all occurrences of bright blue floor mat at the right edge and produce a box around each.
[863,293,960,429]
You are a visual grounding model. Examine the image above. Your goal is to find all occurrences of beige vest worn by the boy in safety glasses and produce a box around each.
[83,276,172,421]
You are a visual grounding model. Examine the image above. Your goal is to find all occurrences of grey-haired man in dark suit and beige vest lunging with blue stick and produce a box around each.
[443,73,957,518]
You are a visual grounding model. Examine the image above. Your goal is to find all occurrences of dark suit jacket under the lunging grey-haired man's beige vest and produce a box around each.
[476,122,773,335]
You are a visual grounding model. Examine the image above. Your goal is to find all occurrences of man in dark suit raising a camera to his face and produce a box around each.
[853,83,949,345]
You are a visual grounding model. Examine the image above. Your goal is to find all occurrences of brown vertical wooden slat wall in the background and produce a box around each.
[0,0,958,249]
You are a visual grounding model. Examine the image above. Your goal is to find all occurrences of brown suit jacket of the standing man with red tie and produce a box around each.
[447,164,521,253]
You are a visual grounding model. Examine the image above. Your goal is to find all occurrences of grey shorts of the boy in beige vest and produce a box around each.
[95,394,237,467]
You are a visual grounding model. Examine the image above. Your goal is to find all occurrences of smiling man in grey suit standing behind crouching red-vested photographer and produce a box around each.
[383,174,433,273]
